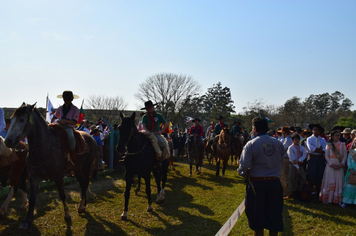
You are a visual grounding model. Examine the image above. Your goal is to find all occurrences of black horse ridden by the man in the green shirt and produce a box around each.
[117,112,170,220]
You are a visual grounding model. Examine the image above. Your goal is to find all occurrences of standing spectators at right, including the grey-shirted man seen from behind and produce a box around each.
[238,117,356,235]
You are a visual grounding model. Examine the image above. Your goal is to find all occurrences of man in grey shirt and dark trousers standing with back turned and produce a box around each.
[237,117,284,236]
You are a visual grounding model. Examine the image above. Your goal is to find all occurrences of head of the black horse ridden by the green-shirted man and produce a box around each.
[117,112,137,153]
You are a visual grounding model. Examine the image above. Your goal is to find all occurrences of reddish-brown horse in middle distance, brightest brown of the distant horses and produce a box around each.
[213,128,231,178]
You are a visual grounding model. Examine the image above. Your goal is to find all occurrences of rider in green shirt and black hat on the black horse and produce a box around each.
[141,100,167,165]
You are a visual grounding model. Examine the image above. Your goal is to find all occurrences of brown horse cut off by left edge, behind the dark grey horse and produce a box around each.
[0,136,28,217]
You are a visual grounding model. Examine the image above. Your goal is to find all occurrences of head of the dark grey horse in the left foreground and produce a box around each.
[5,103,36,147]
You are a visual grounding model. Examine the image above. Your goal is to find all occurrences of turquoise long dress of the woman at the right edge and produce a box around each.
[341,149,356,207]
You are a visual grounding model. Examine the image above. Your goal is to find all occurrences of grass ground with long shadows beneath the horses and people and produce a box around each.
[0,161,356,236]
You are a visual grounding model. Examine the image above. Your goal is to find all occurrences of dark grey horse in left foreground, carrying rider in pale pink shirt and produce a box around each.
[5,105,97,229]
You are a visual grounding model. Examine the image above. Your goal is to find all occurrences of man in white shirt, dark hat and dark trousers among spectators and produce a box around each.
[305,124,326,197]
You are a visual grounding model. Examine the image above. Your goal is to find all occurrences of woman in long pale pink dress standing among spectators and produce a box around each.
[319,130,347,205]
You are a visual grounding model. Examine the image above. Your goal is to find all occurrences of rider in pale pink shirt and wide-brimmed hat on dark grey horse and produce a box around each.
[51,90,79,166]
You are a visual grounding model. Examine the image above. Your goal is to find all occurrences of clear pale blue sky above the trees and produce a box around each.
[0,0,356,113]
